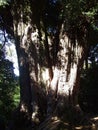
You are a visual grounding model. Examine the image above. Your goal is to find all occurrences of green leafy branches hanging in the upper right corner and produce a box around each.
[60,0,98,29]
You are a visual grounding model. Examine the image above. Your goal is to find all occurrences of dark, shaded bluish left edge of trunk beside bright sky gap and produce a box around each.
[15,26,32,113]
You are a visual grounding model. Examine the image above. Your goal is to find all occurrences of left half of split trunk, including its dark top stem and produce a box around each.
[13,2,45,127]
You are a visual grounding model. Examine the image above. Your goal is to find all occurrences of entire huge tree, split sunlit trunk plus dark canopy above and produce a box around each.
[2,0,98,129]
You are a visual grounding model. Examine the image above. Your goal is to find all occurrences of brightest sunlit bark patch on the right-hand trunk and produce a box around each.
[51,34,83,95]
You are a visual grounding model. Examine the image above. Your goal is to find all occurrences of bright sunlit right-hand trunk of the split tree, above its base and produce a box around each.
[47,24,86,116]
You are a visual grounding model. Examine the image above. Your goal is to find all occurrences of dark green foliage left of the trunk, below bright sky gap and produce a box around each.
[0,50,19,121]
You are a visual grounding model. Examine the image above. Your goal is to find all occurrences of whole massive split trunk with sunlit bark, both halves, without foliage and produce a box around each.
[13,0,87,129]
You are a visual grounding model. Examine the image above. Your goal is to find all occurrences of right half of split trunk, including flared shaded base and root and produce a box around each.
[39,21,87,130]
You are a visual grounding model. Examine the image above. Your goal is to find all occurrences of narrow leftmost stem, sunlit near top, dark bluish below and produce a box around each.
[12,1,32,114]
